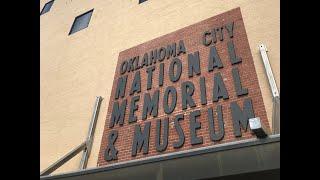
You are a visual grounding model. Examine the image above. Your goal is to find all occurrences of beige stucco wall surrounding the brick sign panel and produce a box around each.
[39,0,280,174]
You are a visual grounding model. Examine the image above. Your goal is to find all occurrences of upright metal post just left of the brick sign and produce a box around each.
[79,96,102,170]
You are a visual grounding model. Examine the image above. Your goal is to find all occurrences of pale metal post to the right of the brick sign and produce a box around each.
[259,44,280,134]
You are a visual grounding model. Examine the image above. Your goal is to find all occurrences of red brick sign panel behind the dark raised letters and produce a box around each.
[98,8,269,166]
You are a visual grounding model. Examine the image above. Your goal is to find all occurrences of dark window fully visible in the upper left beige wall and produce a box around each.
[69,9,93,35]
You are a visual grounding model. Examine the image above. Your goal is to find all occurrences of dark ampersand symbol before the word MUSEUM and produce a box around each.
[104,130,118,161]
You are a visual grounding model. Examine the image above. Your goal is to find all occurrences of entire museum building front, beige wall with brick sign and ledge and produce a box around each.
[40,0,280,180]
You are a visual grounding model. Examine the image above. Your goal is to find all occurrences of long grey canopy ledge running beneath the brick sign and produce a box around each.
[40,134,280,180]
